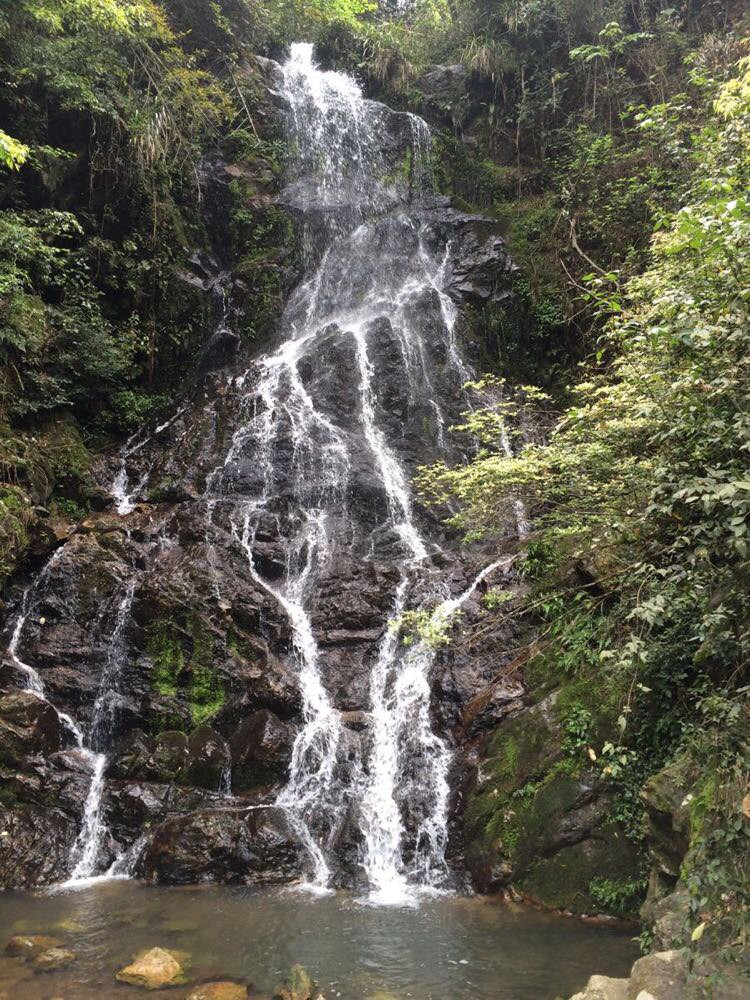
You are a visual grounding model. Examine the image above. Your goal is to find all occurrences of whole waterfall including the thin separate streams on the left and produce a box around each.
[1,44,522,904]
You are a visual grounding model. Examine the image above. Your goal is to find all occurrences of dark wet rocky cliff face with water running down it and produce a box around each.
[0,47,521,887]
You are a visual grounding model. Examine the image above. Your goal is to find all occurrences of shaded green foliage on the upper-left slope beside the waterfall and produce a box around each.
[0,0,241,431]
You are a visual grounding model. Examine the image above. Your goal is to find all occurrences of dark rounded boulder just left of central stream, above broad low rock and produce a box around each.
[229,709,294,791]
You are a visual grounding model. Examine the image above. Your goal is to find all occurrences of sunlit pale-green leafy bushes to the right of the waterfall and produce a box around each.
[419,50,750,947]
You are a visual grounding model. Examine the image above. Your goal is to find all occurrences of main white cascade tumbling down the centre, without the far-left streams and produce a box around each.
[201,44,494,902]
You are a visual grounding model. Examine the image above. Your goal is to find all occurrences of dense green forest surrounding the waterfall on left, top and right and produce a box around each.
[0,0,750,968]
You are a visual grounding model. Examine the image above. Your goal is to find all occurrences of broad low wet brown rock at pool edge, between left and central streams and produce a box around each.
[137,807,300,885]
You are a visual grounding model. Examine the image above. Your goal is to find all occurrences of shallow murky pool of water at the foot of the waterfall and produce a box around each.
[0,881,637,1000]
